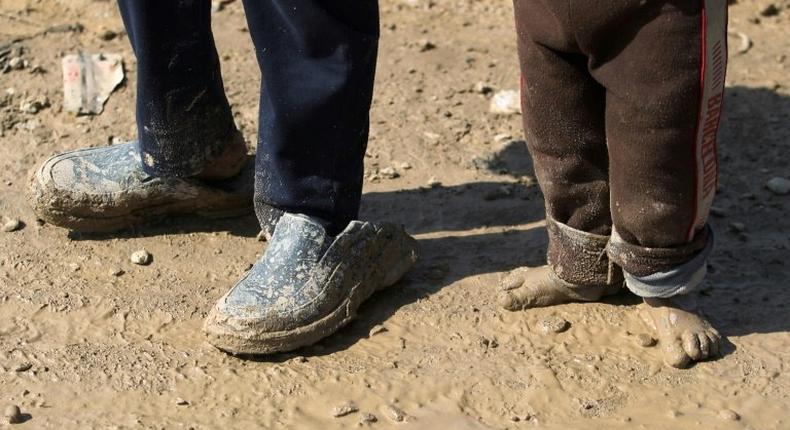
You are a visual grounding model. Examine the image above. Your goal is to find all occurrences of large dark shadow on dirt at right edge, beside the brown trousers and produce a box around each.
[704,87,790,336]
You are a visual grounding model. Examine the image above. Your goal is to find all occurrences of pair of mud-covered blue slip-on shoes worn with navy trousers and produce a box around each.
[31,143,417,354]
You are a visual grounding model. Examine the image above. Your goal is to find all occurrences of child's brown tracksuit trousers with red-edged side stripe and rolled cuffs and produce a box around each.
[514,0,727,297]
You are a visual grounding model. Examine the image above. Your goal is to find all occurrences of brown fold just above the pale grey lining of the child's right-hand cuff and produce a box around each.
[607,226,710,276]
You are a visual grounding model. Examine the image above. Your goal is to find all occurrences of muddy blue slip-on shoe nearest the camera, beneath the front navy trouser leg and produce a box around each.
[203,213,417,354]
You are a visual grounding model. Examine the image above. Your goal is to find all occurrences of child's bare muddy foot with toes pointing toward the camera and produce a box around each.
[640,296,721,368]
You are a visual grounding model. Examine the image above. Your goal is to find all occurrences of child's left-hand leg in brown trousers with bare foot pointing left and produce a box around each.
[500,0,622,310]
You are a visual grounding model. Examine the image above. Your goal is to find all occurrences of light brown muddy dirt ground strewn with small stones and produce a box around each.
[0,0,790,429]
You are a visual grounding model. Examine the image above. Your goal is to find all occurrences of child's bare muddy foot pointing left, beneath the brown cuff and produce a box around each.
[499,266,621,311]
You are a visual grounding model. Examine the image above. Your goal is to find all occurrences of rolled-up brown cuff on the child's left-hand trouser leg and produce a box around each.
[546,217,623,286]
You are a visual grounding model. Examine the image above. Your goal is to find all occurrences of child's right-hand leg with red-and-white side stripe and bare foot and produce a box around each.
[582,0,727,367]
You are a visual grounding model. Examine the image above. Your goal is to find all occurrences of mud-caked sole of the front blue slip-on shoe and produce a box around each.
[203,223,417,355]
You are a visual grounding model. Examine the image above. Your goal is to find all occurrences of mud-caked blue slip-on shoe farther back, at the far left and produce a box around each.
[30,142,254,232]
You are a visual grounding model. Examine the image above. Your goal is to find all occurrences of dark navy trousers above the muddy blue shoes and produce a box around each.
[118,0,379,235]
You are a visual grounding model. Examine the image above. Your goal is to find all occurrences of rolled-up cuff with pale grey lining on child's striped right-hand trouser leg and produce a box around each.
[609,227,714,298]
